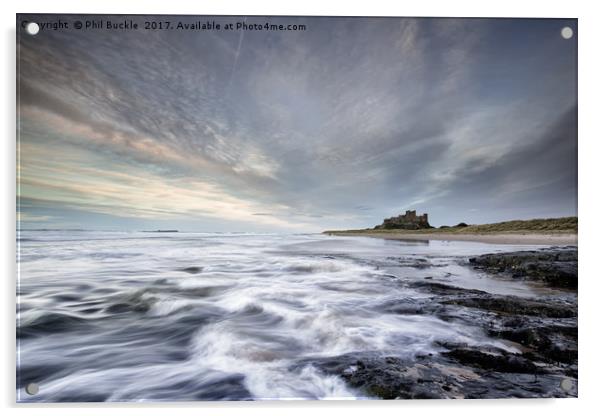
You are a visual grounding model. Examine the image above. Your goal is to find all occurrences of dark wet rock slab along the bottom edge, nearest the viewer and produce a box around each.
[297,349,576,399]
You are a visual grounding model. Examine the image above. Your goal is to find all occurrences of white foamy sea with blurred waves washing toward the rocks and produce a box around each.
[16,230,550,402]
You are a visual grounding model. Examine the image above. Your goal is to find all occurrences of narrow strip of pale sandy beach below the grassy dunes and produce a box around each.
[324,231,577,246]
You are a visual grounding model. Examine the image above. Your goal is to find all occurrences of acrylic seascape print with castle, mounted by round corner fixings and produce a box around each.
[16,14,578,402]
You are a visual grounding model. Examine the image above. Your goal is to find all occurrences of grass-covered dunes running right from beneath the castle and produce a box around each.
[324,217,577,235]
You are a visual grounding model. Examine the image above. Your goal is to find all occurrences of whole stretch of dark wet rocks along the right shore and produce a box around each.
[312,247,578,399]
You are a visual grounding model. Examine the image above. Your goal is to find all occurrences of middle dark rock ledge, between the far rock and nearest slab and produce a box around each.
[404,281,578,368]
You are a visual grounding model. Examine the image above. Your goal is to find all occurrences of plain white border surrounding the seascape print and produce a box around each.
[0,0,602,416]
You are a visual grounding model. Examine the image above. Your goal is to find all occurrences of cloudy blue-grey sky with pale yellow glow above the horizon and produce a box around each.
[17,15,577,232]
